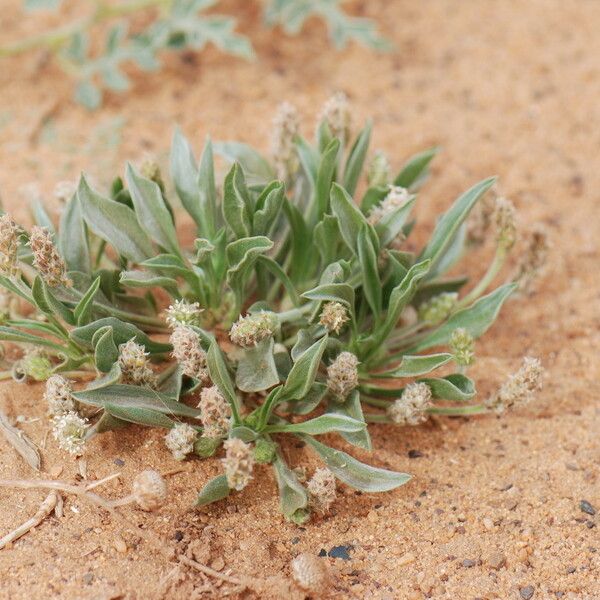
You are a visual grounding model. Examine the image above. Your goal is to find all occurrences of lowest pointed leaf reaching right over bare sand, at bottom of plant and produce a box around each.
[300,435,410,492]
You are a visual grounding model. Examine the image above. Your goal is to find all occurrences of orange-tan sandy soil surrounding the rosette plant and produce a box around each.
[0,0,600,600]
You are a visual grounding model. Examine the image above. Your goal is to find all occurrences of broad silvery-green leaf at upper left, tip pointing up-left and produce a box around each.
[77,176,154,262]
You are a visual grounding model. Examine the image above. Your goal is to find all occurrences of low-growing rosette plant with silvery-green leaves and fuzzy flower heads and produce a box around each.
[0,95,545,523]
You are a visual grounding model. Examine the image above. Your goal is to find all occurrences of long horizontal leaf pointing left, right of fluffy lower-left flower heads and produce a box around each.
[73,384,200,421]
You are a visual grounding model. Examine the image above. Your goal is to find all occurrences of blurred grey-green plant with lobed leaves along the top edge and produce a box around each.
[0,0,390,109]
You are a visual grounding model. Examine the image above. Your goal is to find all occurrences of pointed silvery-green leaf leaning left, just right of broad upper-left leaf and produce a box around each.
[125,163,181,256]
